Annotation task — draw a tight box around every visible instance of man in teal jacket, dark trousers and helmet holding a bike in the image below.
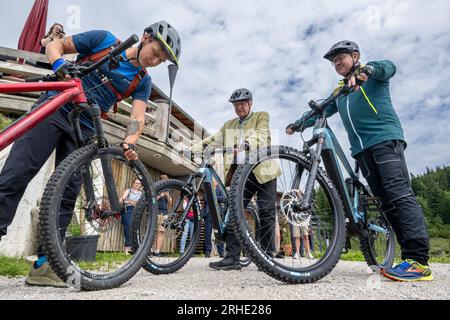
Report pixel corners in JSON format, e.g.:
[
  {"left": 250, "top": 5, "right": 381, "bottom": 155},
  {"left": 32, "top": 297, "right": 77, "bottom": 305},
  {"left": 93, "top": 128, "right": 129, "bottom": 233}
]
[{"left": 286, "top": 41, "right": 433, "bottom": 281}]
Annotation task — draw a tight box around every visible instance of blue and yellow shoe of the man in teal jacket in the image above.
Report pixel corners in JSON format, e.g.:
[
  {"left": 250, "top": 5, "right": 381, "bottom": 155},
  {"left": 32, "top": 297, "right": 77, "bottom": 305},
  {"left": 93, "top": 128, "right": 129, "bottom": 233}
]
[{"left": 381, "top": 260, "right": 433, "bottom": 281}]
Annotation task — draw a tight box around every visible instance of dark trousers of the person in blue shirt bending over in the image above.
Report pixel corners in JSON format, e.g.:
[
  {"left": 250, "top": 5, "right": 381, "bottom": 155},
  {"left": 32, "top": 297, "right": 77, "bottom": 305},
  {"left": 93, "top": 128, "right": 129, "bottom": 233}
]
[{"left": 0, "top": 95, "right": 94, "bottom": 253}]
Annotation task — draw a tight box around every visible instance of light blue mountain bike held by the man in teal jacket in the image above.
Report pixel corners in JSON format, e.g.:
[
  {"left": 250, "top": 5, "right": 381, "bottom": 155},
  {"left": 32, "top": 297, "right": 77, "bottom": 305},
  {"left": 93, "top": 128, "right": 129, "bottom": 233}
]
[{"left": 230, "top": 87, "right": 395, "bottom": 283}]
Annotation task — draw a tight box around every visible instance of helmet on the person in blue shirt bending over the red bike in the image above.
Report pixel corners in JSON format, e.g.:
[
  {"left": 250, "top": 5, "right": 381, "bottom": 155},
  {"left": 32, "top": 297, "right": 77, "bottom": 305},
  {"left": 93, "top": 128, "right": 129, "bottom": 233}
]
[{"left": 144, "top": 21, "right": 181, "bottom": 66}]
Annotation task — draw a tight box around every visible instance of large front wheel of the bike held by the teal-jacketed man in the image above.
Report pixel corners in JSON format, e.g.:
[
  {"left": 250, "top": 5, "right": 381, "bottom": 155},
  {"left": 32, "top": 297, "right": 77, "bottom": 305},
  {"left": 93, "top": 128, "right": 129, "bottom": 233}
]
[{"left": 230, "top": 146, "right": 346, "bottom": 283}]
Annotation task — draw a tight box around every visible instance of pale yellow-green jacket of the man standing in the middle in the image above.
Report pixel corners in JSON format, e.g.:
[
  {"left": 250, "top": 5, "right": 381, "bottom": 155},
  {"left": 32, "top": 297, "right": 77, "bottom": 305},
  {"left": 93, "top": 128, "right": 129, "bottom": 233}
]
[{"left": 191, "top": 112, "right": 281, "bottom": 184}]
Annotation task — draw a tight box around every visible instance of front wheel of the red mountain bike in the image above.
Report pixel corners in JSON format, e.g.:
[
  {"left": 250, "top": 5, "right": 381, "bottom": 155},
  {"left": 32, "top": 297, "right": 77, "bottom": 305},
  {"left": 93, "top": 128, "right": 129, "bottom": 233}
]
[{"left": 39, "top": 144, "right": 156, "bottom": 291}]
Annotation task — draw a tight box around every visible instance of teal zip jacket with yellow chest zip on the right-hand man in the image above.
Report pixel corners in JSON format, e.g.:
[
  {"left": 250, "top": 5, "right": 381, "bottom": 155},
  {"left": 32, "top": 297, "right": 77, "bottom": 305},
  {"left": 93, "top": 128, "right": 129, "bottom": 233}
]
[{"left": 297, "top": 60, "right": 405, "bottom": 156}]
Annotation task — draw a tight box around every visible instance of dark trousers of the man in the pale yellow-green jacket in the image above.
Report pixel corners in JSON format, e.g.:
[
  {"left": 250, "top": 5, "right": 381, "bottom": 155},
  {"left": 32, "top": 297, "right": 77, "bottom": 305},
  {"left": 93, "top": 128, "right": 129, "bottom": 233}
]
[{"left": 225, "top": 173, "right": 277, "bottom": 260}]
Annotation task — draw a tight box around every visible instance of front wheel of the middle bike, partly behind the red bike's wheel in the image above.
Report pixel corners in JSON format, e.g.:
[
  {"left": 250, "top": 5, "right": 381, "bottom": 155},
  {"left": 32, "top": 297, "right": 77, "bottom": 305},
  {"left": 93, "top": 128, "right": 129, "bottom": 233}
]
[{"left": 131, "top": 180, "right": 201, "bottom": 275}]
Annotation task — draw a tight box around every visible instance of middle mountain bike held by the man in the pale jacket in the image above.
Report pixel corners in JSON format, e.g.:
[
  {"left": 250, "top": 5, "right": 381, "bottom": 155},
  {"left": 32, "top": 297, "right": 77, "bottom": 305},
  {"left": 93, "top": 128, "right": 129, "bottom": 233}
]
[{"left": 132, "top": 150, "right": 259, "bottom": 275}]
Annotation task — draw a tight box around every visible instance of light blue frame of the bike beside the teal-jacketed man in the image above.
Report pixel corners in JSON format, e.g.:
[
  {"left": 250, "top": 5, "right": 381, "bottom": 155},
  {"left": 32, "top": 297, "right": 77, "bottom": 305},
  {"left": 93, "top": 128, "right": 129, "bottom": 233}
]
[{"left": 305, "top": 117, "right": 388, "bottom": 233}]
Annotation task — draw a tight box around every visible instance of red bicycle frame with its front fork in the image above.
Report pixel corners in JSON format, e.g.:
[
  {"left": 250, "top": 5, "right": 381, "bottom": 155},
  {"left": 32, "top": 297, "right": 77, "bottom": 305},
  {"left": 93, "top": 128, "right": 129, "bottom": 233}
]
[{"left": 0, "top": 78, "right": 121, "bottom": 212}]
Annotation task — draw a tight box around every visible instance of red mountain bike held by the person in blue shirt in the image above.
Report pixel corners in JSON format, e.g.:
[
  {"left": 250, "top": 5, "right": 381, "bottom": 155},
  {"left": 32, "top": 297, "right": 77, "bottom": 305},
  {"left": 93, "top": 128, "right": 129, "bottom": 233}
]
[{"left": 0, "top": 35, "right": 156, "bottom": 290}]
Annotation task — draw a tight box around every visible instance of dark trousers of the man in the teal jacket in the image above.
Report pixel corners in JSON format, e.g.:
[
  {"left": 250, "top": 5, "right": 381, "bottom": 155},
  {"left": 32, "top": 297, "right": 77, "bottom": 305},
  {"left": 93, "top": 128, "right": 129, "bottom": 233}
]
[{"left": 356, "top": 140, "right": 430, "bottom": 263}]
